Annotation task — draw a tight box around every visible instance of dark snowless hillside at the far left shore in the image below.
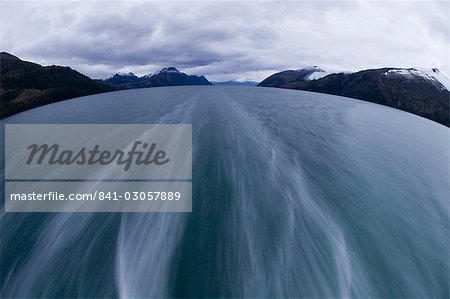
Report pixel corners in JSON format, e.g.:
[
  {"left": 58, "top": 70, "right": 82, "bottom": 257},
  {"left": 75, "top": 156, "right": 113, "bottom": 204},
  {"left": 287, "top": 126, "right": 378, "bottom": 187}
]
[{"left": 0, "top": 52, "right": 113, "bottom": 118}]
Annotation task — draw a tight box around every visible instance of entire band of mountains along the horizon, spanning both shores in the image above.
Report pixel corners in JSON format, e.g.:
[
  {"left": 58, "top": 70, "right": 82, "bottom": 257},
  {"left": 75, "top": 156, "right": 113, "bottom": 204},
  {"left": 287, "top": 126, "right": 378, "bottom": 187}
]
[{"left": 0, "top": 52, "right": 450, "bottom": 127}]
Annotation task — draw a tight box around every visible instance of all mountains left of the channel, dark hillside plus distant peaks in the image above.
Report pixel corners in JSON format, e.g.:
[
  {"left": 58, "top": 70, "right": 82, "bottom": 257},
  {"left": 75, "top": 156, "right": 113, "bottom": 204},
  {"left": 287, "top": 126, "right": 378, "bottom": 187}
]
[{"left": 0, "top": 52, "right": 211, "bottom": 118}]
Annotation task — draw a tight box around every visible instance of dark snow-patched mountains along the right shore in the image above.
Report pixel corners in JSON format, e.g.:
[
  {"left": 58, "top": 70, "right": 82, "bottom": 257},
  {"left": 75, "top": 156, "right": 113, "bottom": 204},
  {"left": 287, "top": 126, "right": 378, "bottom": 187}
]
[{"left": 258, "top": 68, "right": 450, "bottom": 126}]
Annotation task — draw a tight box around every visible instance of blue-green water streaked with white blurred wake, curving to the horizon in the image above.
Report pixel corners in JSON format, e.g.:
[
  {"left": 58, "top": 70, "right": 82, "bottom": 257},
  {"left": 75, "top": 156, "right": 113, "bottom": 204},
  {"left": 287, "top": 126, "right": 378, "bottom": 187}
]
[{"left": 0, "top": 86, "right": 450, "bottom": 298}]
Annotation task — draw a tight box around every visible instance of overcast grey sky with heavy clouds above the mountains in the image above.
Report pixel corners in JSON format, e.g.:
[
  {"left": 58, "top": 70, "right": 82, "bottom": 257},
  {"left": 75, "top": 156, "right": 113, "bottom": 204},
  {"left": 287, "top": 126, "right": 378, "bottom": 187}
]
[{"left": 0, "top": 1, "right": 450, "bottom": 81}]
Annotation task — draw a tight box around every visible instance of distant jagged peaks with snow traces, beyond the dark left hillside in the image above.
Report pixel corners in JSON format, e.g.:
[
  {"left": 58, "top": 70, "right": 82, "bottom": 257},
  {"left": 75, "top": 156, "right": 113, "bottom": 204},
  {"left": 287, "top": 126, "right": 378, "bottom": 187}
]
[{"left": 105, "top": 67, "right": 212, "bottom": 89}]
